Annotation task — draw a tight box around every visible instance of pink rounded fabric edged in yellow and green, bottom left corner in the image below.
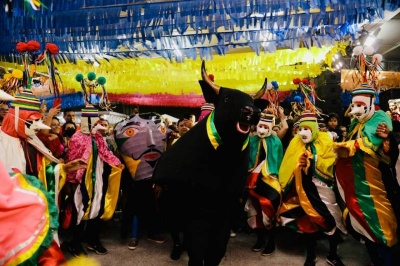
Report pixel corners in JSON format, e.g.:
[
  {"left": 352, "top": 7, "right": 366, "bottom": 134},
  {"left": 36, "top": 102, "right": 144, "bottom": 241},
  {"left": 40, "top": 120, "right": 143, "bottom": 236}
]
[{"left": 0, "top": 163, "right": 65, "bottom": 265}]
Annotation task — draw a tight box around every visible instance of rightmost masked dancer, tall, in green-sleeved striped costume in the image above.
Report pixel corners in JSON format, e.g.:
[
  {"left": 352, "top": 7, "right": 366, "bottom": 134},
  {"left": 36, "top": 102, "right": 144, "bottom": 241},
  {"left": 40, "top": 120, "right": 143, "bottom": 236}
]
[{"left": 335, "top": 84, "right": 400, "bottom": 265}]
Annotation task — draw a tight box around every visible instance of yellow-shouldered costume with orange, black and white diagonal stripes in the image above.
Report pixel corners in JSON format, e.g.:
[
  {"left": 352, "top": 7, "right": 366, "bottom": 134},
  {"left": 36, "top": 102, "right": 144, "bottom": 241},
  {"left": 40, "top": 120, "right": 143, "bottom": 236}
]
[{"left": 279, "top": 132, "right": 346, "bottom": 233}]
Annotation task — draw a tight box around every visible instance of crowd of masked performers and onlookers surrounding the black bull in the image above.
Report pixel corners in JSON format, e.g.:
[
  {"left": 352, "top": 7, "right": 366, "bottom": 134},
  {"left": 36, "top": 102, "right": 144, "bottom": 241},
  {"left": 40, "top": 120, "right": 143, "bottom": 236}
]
[{"left": 0, "top": 79, "right": 400, "bottom": 265}]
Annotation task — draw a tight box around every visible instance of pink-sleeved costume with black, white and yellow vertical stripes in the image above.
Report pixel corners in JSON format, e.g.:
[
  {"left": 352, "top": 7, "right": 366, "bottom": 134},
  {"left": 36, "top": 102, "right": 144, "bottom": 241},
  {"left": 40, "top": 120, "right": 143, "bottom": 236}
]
[{"left": 67, "top": 123, "right": 122, "bottom": 224}]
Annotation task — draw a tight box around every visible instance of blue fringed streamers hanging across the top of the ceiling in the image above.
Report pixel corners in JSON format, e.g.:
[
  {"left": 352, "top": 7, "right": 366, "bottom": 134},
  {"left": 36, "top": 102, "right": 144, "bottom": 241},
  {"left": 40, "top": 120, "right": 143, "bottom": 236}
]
[{"left": 0, "top": 0, "right": 399, "bottom": 61}]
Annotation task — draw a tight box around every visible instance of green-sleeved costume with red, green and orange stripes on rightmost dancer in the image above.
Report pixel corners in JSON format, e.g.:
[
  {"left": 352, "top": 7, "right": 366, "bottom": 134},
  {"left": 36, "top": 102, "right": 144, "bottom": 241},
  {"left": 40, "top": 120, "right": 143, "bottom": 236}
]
[{"left": 335, "top": 110, "right": 399, "bottom": 247}]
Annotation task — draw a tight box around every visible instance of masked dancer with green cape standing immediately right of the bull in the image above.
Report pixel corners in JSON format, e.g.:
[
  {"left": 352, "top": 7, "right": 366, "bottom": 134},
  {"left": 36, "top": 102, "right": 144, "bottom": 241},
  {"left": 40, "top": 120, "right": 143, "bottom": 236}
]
[{"left": 245, "top": 112, "right": 283, "bottom": 256}]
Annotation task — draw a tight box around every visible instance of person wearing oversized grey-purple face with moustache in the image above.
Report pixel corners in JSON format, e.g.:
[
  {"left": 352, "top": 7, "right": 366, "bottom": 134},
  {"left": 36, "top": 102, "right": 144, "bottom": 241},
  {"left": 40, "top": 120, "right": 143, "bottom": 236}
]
[{"left": 114, "top": 113, "right": 167, "bottom": 250}]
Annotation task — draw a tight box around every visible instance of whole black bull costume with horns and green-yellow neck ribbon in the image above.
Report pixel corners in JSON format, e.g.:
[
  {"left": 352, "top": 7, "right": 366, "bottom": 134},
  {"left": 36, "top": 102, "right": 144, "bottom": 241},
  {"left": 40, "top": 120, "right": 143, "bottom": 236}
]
[{"left": 153, "top": 61, "right": 266, "bottom": 265}]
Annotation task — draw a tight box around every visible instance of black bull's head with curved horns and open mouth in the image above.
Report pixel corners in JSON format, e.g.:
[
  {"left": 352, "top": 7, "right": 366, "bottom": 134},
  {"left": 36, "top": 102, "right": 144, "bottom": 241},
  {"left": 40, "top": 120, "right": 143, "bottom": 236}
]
[{"left": 199, "top": 61, "right": 267, "bottom": 141}]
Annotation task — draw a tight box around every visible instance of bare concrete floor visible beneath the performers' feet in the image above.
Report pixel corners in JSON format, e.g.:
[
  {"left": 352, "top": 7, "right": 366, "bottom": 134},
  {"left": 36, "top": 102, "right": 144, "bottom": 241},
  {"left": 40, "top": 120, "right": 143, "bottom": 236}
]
[{"left": 62, "top": 221, "right": 369, "bottom": 266}]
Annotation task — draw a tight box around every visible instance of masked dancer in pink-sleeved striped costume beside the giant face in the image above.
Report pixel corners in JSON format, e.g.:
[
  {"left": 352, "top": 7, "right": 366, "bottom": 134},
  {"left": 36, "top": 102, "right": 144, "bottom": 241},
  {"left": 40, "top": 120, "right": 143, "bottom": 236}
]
[{"left": 65, "top": 104, "right": 124, "bottom": 257}]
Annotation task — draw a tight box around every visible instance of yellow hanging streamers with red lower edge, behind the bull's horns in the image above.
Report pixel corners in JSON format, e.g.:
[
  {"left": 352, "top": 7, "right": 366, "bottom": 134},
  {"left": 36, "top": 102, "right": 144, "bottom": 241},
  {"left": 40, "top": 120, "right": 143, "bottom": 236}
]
[{"left": 1, "top": 43, "right": 346, "bottom": 107}]
